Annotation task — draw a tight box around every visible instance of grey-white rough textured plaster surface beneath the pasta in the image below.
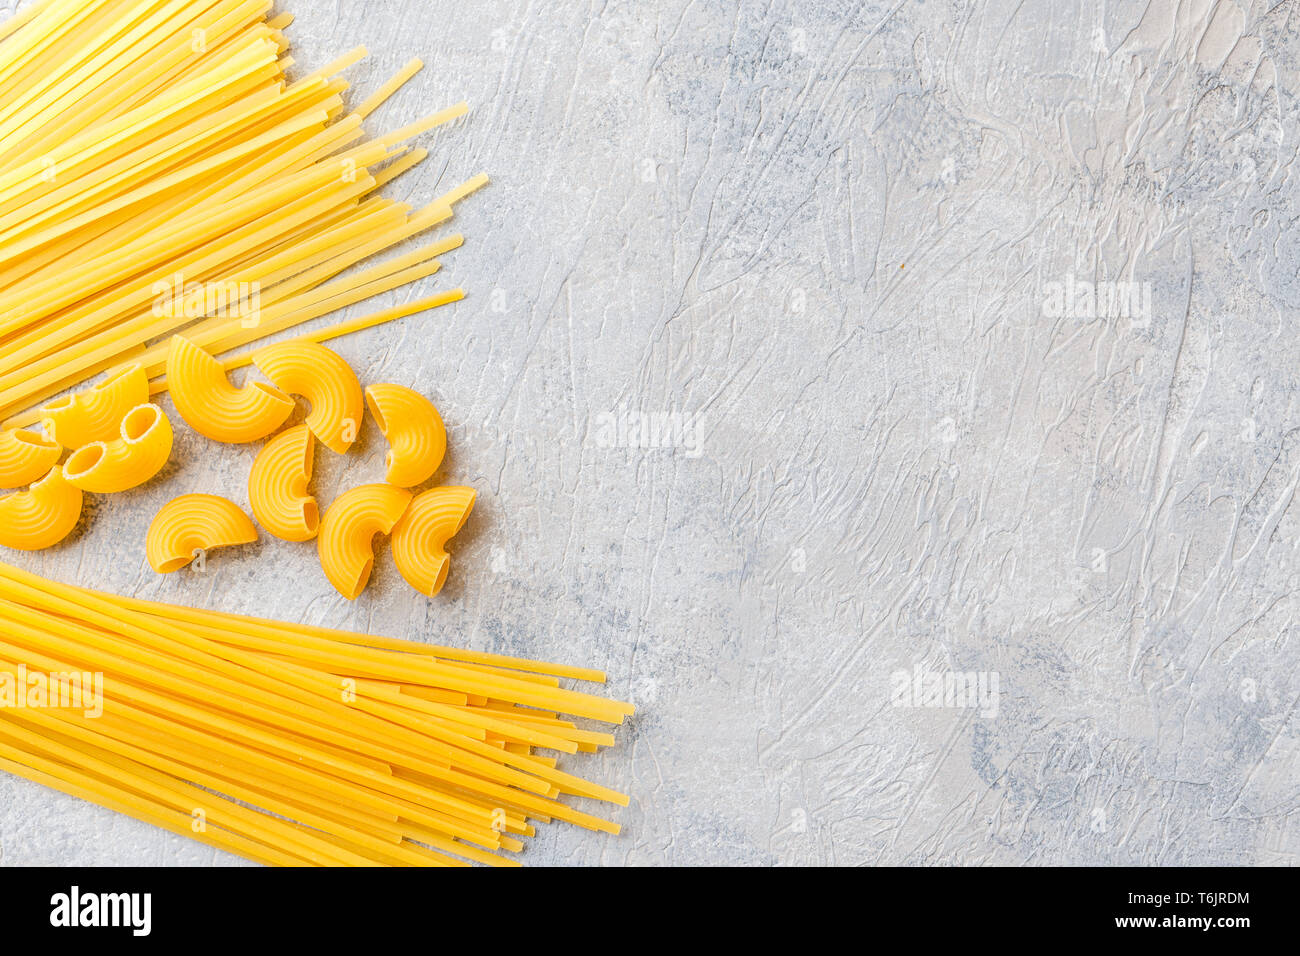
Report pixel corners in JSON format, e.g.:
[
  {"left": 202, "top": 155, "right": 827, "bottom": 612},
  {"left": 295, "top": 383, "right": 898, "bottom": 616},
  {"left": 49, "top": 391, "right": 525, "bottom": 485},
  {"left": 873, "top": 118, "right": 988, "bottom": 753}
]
[{"left": 0, "top": 0, "right": 1300, "bottom": 864}]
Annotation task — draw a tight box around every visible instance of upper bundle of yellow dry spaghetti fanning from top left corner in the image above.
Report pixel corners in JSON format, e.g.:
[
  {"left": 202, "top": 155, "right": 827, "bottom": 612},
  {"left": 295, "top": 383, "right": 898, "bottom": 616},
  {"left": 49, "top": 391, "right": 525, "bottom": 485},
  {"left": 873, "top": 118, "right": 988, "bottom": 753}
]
[{"left": 0, "top": 0, "right": 486, "bottom": 427}]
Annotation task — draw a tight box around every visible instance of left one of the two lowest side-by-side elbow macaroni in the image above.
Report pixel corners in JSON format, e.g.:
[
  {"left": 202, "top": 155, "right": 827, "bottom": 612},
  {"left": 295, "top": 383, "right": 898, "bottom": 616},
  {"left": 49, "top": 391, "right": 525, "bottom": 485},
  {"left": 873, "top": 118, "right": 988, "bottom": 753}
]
[{"left": 316, "top": 484, "right": 411, "bottom": 601}]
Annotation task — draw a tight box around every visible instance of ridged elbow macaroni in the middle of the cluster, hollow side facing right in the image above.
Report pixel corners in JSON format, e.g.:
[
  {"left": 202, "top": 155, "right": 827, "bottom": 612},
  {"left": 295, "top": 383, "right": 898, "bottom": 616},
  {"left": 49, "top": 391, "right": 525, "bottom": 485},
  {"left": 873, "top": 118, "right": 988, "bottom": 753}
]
[{"left": 248, "top": 425, "right": 320, "bottom": 541}]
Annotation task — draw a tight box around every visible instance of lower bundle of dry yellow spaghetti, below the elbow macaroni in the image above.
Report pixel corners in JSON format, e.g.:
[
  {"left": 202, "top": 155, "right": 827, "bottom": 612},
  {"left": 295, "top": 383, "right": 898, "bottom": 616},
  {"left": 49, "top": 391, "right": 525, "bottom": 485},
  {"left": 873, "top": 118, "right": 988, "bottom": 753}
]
[{"left": 0, "top": 563, "right": 633, "bottom": 866}]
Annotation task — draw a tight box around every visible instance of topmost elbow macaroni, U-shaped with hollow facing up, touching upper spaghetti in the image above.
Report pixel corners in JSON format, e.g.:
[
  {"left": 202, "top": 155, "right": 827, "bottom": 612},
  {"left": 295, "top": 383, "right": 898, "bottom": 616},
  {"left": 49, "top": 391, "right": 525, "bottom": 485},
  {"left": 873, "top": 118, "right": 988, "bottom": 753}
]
[{"left": 166, "top": 336, "right": 294, "bottom": 444}]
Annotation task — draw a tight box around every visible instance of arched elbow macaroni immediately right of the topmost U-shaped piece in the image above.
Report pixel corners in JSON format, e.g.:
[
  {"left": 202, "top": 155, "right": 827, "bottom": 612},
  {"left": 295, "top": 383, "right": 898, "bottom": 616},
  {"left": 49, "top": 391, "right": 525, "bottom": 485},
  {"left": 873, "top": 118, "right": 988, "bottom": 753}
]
[{"left": 252, "top": 342, "right": 364, "bottom": 454}]
